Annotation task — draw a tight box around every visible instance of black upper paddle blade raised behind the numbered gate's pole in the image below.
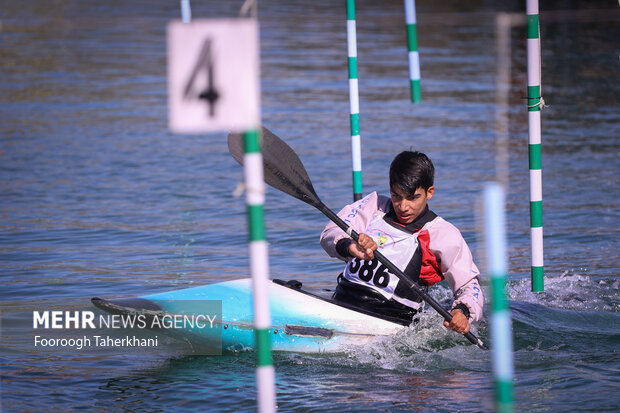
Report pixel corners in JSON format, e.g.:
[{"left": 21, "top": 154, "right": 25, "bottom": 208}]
[{"left": 228, "top": 127, "right": 322, "bottom": 208}]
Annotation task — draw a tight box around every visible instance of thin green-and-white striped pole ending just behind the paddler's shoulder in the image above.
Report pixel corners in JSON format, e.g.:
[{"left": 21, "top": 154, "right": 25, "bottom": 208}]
[{"left": 347, "top": 0, "right": 362, "bottom": 201}]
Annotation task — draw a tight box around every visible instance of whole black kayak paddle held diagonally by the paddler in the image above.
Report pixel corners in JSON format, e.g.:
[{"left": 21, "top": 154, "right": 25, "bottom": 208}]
[{"left": 228, "top": 127, "right": 488, "bottom": 350}]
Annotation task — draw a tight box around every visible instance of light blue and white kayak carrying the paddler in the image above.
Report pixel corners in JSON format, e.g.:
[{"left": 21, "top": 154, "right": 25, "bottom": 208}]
[{"left": 92, "top": 279, "right": 408, "bottom": 353}]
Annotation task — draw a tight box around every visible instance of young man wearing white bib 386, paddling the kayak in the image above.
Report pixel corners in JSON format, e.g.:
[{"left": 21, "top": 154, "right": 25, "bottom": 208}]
[{"left": 321, "top": 151, "right": 484, "bottom": 334}]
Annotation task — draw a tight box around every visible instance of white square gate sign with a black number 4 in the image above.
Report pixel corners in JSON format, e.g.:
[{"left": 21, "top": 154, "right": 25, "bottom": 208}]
[{"left": 168, "top": 19, "right": 260, "bottom": 133}]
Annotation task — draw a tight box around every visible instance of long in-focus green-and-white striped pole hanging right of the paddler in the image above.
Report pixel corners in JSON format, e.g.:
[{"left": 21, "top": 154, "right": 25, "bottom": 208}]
[{"left": 526, "top": 0, "right": 544, "bottom": 292}]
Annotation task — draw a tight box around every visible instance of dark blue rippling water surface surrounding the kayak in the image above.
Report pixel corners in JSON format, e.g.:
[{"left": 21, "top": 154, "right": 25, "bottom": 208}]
[{"left": 0, "top": 0, "right": 620, "bottom": 412}]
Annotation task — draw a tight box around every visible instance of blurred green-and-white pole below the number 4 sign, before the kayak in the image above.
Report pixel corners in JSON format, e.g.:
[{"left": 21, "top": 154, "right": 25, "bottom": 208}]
[{"left": 243, "top": 130, "right": 276, "bottom": 412}]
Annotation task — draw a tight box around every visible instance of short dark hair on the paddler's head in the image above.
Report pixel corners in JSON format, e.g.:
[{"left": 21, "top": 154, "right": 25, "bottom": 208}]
[{"left": 390, "top": 151, "right": 435, "bottom": 195}]
